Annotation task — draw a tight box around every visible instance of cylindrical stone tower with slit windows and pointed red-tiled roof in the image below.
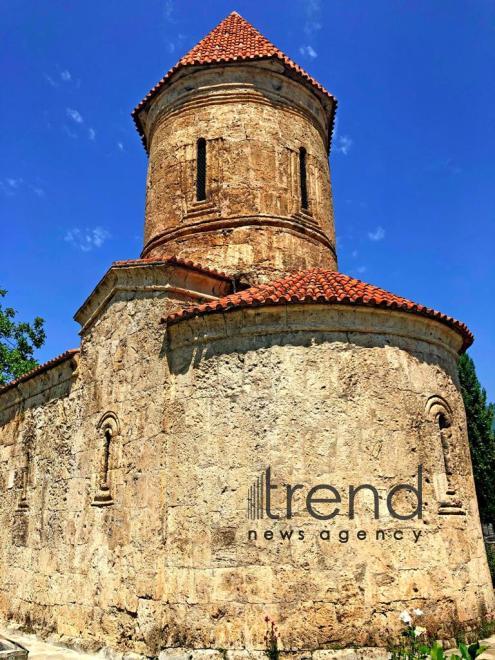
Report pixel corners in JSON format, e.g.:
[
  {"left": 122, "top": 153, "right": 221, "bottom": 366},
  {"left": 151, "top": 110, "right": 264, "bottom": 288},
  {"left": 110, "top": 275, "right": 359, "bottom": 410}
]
[{"left": 134, "top": 12, "right": 337, "bottom": 283}]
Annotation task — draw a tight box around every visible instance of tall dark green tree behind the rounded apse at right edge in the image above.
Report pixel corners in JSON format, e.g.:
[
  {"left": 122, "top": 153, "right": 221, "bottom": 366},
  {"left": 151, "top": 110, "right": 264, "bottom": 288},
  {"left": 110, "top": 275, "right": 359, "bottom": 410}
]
[{"left": 459, "top": 353, "right": 495, "bottom": 523}]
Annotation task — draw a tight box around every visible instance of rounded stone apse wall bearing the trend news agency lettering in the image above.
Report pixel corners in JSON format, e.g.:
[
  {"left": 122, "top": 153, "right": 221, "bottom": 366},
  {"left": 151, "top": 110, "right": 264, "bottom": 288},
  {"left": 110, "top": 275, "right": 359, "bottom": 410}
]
[{"left": 161, "top": 305, "right": 494, "bottom": 649}]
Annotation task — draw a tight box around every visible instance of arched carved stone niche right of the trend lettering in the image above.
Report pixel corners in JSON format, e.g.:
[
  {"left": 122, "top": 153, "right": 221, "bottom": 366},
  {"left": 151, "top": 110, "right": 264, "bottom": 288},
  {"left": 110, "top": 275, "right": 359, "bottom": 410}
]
[{"left": 426, "top": 394, "right": 466, "bottom": 516}]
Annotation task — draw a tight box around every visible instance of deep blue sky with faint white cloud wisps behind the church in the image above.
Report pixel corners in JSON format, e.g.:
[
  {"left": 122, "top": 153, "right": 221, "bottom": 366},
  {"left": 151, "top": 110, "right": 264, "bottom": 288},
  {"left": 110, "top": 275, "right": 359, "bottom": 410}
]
[{"left": 0, "top": 0, "right": 495, "bottom": 400}]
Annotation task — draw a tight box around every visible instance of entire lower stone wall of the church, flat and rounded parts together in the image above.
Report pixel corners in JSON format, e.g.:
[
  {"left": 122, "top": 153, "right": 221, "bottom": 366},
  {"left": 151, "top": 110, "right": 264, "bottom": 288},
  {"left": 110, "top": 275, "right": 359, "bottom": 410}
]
[{"left": 0, "top": 292, "right": 493, "bottom": 655}]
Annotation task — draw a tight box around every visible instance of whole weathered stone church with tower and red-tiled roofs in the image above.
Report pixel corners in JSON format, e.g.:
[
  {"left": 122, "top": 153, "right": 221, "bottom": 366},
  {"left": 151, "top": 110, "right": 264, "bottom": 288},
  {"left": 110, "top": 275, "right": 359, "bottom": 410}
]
[{"left": 0, "top": 13, "right": 494, "bottom": 658}]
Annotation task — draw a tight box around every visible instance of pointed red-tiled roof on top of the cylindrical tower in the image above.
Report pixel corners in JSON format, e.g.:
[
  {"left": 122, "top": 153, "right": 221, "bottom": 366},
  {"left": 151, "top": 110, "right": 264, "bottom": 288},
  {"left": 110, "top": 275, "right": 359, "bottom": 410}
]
[{"left": 132, "top": 11, "right": 336, "bottom": 147}]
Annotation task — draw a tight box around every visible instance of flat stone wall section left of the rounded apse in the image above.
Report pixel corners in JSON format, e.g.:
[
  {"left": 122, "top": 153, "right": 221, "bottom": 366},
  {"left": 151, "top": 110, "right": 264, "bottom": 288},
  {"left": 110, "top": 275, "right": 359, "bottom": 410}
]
[{"left": 0, "top": 284, "right": 200, "bottom": 652}]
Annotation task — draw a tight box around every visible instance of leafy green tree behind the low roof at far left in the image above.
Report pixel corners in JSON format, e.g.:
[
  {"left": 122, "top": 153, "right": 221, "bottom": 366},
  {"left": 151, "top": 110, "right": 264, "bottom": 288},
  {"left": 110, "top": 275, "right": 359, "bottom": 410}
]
[{"left": 0, "top": 289, "right": 46, "bottom": 385}]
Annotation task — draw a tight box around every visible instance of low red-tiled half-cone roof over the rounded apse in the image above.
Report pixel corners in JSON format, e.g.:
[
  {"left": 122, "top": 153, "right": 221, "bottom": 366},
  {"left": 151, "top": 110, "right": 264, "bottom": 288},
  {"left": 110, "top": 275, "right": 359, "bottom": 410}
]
[{"left": 164, "top": 268, "right": 473, "bottom": 351}]
